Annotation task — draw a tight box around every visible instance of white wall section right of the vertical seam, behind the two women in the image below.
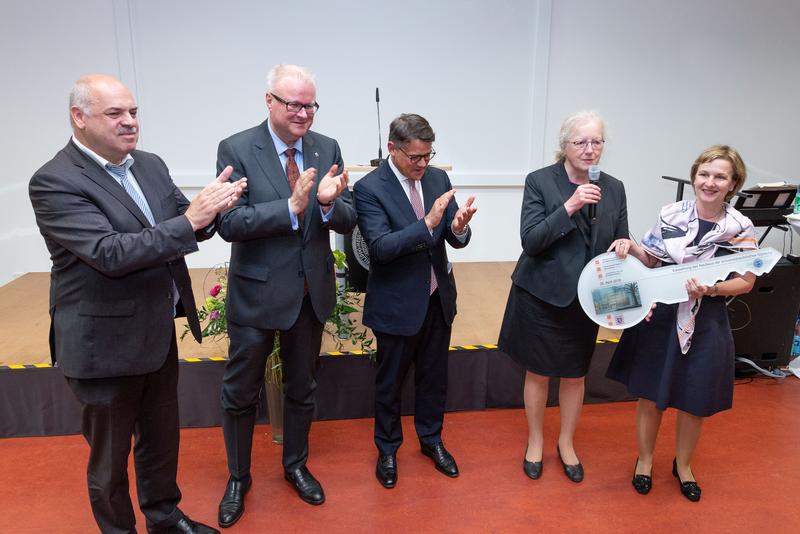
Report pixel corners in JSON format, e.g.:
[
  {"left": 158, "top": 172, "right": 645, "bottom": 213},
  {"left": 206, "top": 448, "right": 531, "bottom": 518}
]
[{"left": 546, "top": 0, "right": 800, "bottom": 247}]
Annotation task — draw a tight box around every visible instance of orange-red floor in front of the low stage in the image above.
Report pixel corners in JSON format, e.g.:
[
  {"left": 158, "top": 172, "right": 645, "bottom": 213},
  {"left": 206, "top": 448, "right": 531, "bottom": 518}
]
[{"left": 0, "top": 377, "right": 800, "bottom": 534}]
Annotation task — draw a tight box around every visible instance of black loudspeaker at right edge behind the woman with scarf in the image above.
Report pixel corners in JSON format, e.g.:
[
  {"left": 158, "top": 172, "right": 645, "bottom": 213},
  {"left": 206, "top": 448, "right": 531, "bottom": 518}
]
[{"left": 728, "top": 258, "right": 800, "bottom": 368}]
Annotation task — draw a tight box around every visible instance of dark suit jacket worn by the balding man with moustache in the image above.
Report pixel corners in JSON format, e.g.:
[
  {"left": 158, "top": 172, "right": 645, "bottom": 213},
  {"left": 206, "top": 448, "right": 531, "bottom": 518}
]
[{"left": 29, "top": 141, "right": 210, "bottom": 378}]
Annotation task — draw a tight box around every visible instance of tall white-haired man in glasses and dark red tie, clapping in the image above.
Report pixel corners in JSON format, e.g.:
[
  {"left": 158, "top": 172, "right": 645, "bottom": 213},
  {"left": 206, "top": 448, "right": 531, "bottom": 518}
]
[{"left": 217, "top": 65, "right": 355, "bottom": 527}]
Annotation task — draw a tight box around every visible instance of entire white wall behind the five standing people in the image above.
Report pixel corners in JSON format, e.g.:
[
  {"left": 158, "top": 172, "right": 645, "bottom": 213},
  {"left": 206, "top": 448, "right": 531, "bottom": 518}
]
[{"left": 0, "top": 0, "right": 800, "bottom": 284}]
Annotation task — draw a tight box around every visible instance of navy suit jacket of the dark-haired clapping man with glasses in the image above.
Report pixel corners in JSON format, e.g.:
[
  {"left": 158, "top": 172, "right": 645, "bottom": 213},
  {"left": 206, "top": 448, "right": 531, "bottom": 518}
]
[{"left": 353, "top": 161, "right": 472, "bottom": 336}]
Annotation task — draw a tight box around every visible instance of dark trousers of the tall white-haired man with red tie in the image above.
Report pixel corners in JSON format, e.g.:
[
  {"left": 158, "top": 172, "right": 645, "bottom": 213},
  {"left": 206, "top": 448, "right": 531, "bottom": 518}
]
[{"left": 222, "top": 296, "right": 323, "bottom": 479}]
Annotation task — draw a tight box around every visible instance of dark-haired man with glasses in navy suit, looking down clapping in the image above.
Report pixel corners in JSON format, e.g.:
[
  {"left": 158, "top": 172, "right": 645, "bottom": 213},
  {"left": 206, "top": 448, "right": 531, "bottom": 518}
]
[{"left": 353, "top": 114, "right": 477, "bottom": 488}]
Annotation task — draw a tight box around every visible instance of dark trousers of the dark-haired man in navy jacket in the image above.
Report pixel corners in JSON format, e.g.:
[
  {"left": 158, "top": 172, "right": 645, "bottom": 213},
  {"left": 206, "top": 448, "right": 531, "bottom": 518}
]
[{"left": 375, "top": 292, "right": 451, "bottom": 455}]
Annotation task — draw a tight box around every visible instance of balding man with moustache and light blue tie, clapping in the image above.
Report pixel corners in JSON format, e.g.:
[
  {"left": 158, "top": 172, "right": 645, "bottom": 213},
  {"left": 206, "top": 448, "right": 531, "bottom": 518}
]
[{"left": 29, "top": 75, "right": 244, "bottom": 533}]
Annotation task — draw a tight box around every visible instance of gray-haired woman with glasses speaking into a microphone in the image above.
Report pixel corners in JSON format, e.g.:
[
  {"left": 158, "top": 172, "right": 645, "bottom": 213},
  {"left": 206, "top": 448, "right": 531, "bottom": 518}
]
[{"left": 498, "top": 111, "right": 628, "bottom": 482}]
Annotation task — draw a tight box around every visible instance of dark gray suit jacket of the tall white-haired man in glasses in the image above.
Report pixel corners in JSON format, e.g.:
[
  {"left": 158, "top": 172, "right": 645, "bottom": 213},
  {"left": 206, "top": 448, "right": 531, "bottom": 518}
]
[{"left": 217, "top": 121, "right": 356, "bottom": 330}]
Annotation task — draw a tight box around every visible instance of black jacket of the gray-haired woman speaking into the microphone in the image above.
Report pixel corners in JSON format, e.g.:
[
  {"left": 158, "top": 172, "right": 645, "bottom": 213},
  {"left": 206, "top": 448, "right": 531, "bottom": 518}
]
[{"left": 511, "top": 162, "right": 628, "bottom": 307}]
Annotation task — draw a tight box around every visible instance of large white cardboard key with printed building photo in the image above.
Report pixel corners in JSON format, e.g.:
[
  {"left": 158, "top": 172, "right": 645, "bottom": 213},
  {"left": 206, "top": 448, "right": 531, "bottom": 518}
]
[{"left": 578, "top": 247, "right": 781, "bottom": 329}]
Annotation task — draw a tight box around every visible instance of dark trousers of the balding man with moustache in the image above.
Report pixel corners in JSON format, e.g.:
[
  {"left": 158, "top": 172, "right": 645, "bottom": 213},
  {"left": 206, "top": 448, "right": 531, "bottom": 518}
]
[{"left": 67, "top": 334, "right": 183, "bottom": 533}]
